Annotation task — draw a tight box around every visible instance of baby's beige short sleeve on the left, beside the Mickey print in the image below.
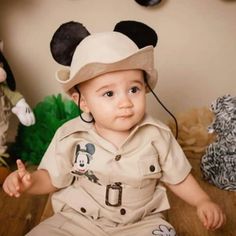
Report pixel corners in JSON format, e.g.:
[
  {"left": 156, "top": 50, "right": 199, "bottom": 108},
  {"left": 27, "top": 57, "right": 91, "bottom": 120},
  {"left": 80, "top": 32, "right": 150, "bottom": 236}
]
[{"left": 38, "top": 128, "right": 73, "bottom": 188}]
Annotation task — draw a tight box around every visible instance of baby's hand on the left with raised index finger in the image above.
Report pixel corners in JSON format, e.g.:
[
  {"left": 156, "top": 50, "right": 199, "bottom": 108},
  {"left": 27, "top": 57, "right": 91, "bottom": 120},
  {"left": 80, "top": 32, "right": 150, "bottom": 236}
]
[{"left": 3, "top": 160, "right": 32, "bottom": 197}]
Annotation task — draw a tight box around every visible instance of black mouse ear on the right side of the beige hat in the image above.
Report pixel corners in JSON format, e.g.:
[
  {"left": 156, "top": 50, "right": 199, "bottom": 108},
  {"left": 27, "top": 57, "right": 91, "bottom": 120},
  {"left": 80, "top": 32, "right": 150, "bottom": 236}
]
[{"left": 114, "top": 21, "right": 158, "bottom": 48}]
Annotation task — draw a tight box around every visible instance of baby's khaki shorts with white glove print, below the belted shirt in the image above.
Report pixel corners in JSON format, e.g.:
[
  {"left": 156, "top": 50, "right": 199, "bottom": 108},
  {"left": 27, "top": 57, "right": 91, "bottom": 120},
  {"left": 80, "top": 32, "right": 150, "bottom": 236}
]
[{"left": 27, "top": 208, "right": 176, "bottom": 236}]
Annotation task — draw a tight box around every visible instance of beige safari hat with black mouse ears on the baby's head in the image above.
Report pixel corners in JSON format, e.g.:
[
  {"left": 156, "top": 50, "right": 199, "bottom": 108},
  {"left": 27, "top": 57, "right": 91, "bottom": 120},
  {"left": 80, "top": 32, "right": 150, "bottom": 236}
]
[{"left": 50, "top": 21, "right": 158, "bottom": 94}]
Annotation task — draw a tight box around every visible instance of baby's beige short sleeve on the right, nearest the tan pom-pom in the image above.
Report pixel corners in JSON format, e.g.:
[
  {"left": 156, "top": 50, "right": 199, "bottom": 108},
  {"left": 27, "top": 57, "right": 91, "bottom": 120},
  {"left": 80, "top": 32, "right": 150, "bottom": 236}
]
[{"left": 155, "top": 130, "right": 191, "bottom": 184}]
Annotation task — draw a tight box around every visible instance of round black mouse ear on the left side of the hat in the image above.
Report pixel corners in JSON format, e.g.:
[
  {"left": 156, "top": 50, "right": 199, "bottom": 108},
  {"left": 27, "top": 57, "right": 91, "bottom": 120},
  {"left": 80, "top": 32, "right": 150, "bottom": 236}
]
[{"left": 50, "top": 21, "right": 90, "bottom": 66}]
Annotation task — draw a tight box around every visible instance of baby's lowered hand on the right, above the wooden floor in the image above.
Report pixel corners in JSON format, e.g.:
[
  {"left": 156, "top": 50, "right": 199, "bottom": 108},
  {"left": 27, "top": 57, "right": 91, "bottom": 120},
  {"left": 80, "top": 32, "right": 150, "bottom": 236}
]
[{"left": 197, "top": 199, "right": 226, "bottom": 230}]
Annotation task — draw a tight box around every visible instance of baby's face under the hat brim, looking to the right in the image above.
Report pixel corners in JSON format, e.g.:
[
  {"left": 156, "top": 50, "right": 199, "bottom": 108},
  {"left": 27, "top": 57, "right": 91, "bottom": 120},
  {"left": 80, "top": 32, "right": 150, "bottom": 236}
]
[{"left": 72, "top": 70, "right": 146, "bottom": 131}]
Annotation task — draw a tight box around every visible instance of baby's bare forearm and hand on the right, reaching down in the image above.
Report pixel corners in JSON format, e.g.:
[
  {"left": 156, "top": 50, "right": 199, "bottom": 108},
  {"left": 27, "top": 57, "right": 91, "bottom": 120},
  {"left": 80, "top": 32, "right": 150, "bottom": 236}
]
[{"left": 167, "top": 174, "right": 225, "bottom": 230}]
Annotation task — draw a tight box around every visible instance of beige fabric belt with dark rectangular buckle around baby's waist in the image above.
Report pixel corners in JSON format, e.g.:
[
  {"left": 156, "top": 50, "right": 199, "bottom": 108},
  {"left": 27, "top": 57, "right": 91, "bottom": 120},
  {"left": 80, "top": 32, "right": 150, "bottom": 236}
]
[{"left": 79, "top": 178, "right": 156, "bottom": 207}]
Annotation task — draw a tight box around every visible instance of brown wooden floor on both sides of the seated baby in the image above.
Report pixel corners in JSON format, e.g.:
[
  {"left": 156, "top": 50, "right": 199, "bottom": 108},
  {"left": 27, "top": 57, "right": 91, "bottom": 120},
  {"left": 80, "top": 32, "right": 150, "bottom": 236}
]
[{"left": 0, "top": 158, "right": 236, "bottom": 236}]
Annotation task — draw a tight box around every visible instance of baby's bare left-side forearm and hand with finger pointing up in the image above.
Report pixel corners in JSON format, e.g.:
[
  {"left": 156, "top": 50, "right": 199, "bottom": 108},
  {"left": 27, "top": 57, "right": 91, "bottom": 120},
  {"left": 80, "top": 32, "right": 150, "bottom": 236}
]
[{"left": 3, "top": 160, "right": 57, "bottom": 197}]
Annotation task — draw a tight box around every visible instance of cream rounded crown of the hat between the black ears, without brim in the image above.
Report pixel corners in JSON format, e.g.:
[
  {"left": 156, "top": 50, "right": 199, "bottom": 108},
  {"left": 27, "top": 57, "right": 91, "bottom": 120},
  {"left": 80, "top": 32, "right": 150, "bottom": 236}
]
[{"left": 70, "top": 31, "right": 139, "bottom": 78}]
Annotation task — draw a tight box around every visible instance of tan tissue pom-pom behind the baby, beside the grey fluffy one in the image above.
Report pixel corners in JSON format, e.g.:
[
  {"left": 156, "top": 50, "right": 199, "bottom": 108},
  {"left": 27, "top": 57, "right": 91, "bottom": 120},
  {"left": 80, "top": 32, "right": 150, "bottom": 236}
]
[{"left": 169, "top": 107, "right": 215, "bottom": 158}]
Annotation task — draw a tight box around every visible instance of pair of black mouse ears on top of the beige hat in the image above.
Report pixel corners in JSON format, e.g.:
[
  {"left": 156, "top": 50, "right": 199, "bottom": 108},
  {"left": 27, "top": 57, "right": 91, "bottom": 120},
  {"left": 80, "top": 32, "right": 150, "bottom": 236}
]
[{"left": 50, "top": 21, "right": 158, "bottom": 66}]
